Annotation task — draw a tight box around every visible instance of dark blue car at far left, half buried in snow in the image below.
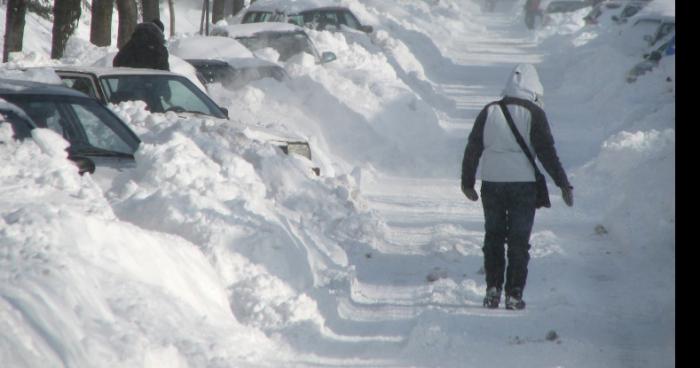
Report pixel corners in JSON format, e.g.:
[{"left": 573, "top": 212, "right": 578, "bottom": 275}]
[{"left": 0, "top": 79, "right": 141, "bottom": 173}]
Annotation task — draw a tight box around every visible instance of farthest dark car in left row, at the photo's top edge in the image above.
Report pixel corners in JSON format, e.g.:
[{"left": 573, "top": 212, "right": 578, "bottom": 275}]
[{"left": 241, "top": 0, "right": 374, "bottom": 33}]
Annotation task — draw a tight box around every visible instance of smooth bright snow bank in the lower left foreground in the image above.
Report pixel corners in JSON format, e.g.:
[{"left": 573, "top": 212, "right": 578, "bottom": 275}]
[{"left": 0, "top": 124, "right": 278, "bottom": 367}]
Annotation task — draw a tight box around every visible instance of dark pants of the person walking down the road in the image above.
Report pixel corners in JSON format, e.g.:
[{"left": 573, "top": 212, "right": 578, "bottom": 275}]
[{"left": 481, "top": 181, "right": 537, "bottom": 295}]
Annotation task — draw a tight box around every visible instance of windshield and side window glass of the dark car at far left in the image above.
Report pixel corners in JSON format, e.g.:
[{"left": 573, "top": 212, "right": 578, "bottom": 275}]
[{"left": 2, "top": 95, "right": 140, "bottom": 154}]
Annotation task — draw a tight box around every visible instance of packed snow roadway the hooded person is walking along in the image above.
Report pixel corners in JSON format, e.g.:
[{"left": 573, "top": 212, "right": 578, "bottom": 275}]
[{"left": 278, "top": 8, "right": 674, "bottom": 367}]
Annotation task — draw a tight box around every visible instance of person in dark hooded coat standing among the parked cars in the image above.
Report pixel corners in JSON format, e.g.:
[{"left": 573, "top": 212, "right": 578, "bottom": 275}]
[{"left": 112, "top": 19, "right": 170, "bottom": 70}]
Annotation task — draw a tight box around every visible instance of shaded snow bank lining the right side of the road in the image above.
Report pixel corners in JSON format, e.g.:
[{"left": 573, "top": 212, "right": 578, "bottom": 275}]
[{"left": 541, "top": 0, "right": 676, "bottom": 252}]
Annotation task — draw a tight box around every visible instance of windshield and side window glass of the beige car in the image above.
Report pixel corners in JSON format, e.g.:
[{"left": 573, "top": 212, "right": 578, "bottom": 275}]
[{"left": 95, "top": 74, "right": 226, "bottom": 119}]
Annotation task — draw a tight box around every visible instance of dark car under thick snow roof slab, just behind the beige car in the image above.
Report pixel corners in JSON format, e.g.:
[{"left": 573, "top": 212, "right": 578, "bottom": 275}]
[{"left": 169, "top": 36, "right": 289, "bottom": 89}]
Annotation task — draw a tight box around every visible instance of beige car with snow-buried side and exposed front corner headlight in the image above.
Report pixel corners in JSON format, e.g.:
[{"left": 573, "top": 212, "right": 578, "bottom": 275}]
[{"left": 53, "top": 66, "right": 318, "bottom": 171}]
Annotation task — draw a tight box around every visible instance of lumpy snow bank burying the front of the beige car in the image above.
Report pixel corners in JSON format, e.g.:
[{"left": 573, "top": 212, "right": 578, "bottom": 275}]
[{"left": 107, "top": 103, "right": 382, "bottom": 336}]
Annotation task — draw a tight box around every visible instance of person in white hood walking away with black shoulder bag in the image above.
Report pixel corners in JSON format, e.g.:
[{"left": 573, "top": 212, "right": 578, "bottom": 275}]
[{"left": 461, "top": 64, "right": 574, "bottom": 309}]
